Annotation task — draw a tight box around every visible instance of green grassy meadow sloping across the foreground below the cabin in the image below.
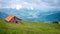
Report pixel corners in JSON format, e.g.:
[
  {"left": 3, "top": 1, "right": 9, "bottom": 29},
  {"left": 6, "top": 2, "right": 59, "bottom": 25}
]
[{"left": 0, "top": 18, "right": 60, "bottom": 34}]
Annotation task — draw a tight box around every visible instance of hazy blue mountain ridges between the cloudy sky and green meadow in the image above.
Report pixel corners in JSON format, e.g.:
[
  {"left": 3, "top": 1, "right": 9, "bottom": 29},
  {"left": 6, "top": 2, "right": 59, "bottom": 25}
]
[{"left": 0, "top": 8, "right": 60, "bottom": 21}]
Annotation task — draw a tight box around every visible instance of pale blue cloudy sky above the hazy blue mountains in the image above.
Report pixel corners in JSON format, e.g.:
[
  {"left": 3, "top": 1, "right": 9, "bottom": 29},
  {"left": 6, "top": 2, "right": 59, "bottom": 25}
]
[{"left": 0, "top": 0, "right": 60, "bottom": 10}]
